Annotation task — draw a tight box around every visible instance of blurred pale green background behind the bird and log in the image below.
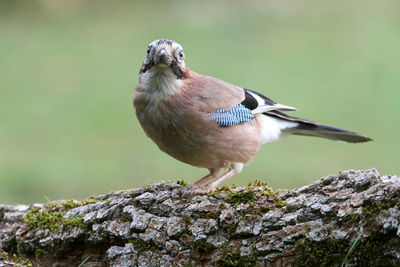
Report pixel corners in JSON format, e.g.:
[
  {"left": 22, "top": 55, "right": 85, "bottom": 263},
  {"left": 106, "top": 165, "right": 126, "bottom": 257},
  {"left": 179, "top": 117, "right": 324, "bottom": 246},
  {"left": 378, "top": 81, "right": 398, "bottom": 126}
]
[{"left": 0, "top": 0, "right": 400, "bottom": 203}]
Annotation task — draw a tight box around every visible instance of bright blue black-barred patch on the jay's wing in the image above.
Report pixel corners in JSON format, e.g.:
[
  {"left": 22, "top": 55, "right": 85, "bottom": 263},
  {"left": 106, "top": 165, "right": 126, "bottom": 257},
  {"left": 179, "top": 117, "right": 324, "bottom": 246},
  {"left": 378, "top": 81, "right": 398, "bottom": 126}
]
[{"left": 208, "top": 104, "right": 254, "bottom": 127}]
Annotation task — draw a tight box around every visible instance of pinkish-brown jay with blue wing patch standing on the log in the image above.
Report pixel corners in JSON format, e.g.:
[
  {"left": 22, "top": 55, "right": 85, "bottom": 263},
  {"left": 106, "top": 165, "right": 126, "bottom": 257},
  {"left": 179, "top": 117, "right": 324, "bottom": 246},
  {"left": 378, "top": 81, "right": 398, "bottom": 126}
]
[{"left": 133, "top": 39, "right": 372, "bottom": 193}]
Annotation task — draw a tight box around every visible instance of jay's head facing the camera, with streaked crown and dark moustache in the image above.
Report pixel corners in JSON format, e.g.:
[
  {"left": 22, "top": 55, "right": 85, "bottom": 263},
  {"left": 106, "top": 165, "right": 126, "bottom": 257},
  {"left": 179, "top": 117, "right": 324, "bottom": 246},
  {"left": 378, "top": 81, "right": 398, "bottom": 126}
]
[{"left": 140, "top": 39, "right": 188, "bottom": 79}]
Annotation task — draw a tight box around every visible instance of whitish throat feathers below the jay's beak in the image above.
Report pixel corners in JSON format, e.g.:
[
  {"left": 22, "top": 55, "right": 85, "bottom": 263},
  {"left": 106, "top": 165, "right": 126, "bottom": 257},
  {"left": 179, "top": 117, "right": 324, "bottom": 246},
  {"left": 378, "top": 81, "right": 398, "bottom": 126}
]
[{"left": 140, "top": 65, "right": 181, "bottom": 102}]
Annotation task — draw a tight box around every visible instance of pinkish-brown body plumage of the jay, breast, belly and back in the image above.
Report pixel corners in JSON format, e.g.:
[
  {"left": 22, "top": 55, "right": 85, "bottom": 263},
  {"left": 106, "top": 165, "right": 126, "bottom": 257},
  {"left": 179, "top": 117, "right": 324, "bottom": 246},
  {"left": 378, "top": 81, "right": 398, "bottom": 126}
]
[{"left": 134, "top": 72, "right": 261, "bottom": 169}]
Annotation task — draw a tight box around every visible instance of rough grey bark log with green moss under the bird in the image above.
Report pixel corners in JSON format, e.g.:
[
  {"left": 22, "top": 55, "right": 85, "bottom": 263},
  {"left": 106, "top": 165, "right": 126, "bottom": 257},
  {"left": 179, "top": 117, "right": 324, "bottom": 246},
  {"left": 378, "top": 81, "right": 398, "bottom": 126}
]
[{"left": 0, "top": 169, "right": 400, "bottom": 266}]
